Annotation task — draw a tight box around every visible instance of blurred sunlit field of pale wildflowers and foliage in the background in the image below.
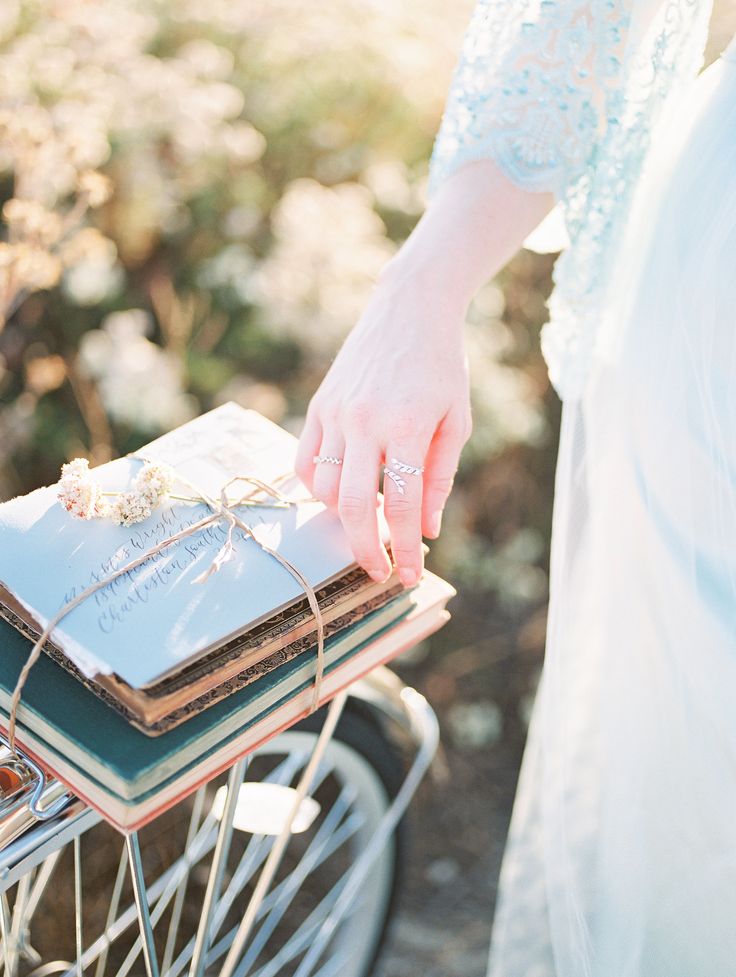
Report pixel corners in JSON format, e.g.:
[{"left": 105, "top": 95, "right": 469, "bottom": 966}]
[{"left": 0, "top": 0, "right": 736, "bottom": 977}]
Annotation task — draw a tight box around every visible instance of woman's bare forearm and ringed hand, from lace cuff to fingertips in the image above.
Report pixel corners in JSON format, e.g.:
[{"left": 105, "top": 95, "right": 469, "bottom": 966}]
[{"left": 296, "top": 159, "right": 554, "bottom": 586}]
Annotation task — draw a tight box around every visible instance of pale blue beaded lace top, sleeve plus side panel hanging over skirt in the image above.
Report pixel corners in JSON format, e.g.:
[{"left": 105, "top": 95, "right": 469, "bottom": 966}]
[{"left": 428, "top": 0, "right": 712, "bottom": 399}]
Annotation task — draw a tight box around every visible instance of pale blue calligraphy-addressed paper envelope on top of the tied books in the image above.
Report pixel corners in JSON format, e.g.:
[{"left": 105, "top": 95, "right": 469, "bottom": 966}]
[{"left": 0, "top": 403, "right": 390, "bottom": 688}]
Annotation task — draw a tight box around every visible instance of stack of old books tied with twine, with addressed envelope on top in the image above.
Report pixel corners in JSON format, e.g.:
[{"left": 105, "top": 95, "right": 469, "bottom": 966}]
[{"left": 0, "top": 403, "right": 455, "bottom": 830}]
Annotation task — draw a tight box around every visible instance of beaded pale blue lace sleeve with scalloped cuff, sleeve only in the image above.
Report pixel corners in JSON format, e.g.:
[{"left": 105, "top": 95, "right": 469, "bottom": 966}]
[{"left": 428, "top": 0, "right": 633, "bottom": 199}]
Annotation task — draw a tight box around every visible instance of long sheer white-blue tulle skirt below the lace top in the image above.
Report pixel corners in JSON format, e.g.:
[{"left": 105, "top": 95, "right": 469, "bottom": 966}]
[{"left": 488, "top": 42, "right": 736, "bottom": 977}]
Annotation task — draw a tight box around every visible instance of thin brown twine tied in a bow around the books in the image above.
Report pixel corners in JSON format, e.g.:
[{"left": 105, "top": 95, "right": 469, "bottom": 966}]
[{"left": 8, "top": 453, "right": 325, "bottom": 751}]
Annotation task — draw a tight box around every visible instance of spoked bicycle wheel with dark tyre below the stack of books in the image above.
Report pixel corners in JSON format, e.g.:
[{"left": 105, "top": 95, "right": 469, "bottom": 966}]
[{"left": 2, "top": 705, "right": 405, "bottom": 977}]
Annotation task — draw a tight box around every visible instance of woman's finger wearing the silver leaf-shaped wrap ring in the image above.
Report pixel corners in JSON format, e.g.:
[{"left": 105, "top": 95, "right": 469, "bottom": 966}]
[{"left": 383, "top": 430, "right": 427, "bottom": 586}]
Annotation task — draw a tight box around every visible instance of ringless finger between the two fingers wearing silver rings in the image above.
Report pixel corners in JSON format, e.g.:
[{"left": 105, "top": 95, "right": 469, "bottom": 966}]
[{"left": 337, "top": 432, "right": 392, "bottom": 581}]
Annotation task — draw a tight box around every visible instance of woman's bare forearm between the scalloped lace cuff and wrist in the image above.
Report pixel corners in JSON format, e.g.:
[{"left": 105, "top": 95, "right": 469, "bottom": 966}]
[{"left": 381, "top": 159, "right": 554, "bottom": 310}]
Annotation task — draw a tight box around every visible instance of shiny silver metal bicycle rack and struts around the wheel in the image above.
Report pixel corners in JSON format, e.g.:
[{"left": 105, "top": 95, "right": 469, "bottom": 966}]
[{"left": 0, "top": 666, "right": 439, "bottom": 977}]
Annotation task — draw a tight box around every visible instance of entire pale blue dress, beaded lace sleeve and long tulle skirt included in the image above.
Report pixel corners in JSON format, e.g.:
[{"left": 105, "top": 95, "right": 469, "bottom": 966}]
[{"left": 431, "top": 0, "right": 736, "bottom": 977}]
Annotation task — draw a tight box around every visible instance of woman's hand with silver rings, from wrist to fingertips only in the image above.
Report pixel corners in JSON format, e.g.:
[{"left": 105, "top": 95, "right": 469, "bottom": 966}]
[{"left": 296, "top": 255, "right": 472, "bottom": 586}]
